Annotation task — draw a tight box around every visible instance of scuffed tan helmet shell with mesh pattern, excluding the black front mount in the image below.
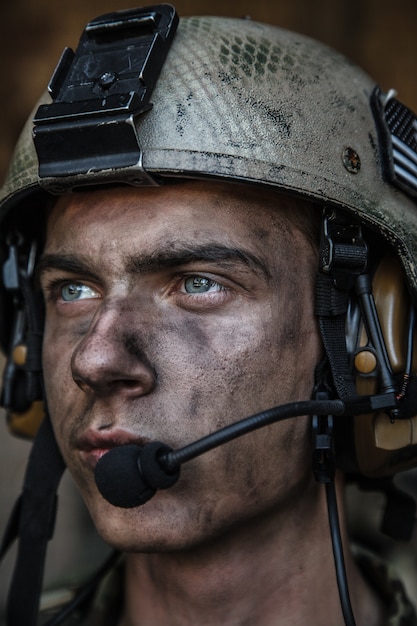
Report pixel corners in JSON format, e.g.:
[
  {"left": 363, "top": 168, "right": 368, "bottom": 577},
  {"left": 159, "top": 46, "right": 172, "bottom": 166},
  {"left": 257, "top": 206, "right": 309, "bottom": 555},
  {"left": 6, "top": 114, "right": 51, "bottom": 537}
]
[{"left": 0, "top": 17, "right": 417, "bottom": 294}]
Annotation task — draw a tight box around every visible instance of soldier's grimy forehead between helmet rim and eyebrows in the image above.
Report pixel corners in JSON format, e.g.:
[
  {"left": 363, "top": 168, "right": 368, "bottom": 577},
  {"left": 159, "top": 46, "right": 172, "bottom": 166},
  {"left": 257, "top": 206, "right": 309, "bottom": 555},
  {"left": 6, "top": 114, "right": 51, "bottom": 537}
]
[{"left": 46, "top": 181, "right": 312, "bottom": 260}]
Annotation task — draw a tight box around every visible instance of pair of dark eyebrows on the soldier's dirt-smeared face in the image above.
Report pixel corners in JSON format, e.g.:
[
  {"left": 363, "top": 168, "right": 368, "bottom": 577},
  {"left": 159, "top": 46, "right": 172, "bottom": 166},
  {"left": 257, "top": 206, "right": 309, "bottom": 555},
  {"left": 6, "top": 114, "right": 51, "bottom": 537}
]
[{"left": 36, "top": 243, "right": 271, "bottom": 279}]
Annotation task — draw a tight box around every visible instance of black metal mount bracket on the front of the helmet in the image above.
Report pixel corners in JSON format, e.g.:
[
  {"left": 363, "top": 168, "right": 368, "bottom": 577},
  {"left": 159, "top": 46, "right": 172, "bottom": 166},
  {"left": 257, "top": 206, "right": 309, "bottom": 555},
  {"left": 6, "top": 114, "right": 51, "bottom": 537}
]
[{"left": 33, "top": 4, "right": 178, "bottom": 193}]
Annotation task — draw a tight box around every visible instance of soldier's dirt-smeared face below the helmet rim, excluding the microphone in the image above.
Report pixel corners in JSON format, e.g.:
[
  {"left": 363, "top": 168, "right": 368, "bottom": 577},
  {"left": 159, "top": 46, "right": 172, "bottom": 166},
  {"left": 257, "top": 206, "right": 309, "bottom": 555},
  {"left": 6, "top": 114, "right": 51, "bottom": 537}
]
[{"left": 41, "top": 183, "right": 320, "bottom": 550}]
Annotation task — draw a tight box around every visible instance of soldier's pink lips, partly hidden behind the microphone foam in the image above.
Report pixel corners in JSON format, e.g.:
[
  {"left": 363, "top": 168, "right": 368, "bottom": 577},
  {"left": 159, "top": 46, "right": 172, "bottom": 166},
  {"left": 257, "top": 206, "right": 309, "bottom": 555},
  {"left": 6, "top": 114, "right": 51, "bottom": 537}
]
[{"left": 76, "top": 430, "right": 146, "bottom": 469}]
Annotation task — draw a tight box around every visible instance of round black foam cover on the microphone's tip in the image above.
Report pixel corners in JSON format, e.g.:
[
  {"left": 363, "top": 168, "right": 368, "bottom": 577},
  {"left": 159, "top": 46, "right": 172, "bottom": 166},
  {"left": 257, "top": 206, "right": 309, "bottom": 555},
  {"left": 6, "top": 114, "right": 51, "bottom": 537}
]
[{"left": 94, "top": 442, "right": 180, "bottom": 509}]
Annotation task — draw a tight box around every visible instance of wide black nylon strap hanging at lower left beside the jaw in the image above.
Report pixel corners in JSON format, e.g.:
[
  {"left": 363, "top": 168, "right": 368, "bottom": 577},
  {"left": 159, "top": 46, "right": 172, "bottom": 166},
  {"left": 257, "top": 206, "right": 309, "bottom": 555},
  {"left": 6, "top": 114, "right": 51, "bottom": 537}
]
[{"left": 3, "top": 417, "right": 65, "bottom": 626}]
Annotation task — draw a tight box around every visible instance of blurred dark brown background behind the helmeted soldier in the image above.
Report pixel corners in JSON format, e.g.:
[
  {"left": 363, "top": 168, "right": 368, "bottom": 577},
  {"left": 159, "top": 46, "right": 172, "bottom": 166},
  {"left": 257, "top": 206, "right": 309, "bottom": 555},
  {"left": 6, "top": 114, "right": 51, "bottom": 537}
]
[{"left": 0, "top": 0, "right": 417, "bottom": 621}]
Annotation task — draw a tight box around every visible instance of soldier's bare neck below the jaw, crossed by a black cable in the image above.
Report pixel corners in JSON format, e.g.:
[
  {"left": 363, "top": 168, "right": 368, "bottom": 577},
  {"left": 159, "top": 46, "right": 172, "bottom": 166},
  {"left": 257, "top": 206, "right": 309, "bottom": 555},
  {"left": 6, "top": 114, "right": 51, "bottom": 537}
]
[{"left": 120, "top": 472, "right": 380, "bottom": 626}]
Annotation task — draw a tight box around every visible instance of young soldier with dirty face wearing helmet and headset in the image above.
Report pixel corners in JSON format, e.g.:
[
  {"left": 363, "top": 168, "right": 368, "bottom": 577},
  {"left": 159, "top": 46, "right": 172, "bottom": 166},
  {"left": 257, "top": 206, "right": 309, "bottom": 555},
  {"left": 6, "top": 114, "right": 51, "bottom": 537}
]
[{"left": 0, "top": 5, "right": 417, "bottom": 626}]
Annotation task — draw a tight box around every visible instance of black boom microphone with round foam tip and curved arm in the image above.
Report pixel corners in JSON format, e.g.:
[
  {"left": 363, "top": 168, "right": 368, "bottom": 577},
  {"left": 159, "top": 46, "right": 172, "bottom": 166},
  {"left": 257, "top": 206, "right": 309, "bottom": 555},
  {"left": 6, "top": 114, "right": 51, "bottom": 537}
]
[{"left": 95, "top": 400, "right": 346, "bottom": 508}]
